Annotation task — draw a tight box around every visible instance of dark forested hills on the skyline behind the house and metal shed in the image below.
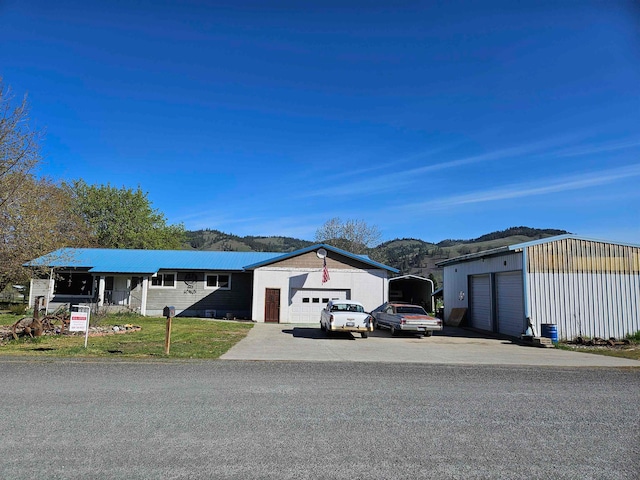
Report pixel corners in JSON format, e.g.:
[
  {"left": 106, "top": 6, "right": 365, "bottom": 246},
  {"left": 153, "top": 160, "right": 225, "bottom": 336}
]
[{"left": 185, "top": 227, "right": 568, "bottom": 284}]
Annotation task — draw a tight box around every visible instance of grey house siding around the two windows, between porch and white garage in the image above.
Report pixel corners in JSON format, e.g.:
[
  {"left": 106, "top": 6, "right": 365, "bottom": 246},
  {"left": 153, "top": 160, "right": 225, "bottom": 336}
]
[{"left": 147, "top": 270, "right": 253, "bottom": 318}]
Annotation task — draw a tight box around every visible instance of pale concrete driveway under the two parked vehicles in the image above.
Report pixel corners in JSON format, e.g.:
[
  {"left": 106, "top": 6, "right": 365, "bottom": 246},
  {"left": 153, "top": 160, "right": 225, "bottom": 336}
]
[{"left": 221, "top": 323, "right": 640, "bottom": 367}]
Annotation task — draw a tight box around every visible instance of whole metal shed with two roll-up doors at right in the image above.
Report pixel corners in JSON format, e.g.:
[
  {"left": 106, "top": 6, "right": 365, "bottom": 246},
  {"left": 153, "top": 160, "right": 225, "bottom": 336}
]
[{"left": 438, "top": 235, "right": 640, "bottom": 339}]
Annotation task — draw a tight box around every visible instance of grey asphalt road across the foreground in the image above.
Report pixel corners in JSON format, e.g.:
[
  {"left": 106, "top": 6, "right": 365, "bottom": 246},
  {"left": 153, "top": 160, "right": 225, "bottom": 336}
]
[{"left": 0, "top": 358, "right": 640, "bottom": 479}]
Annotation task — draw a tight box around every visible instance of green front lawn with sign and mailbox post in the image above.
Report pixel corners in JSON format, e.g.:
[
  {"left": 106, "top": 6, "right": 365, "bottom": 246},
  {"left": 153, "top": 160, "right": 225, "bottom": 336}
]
[{"left": 0, "top": 315, "right": 253, "bottom": 359}]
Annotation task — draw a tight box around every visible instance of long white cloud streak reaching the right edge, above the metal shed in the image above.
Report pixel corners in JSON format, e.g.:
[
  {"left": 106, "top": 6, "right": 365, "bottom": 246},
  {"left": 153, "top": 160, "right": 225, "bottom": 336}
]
[{"left": 404, "top": 164, "right": 640, "bottom": 209}]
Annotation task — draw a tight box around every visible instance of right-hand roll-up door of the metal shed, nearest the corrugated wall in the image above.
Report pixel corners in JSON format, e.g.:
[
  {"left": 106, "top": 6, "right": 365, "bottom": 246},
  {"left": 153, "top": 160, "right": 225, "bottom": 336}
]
[{"left": 496, "top": 272, "right": 525, "bottom": 337}]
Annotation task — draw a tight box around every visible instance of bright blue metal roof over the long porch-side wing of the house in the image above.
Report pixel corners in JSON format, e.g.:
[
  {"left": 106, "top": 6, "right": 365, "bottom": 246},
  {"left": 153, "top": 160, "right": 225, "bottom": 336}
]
[{"left": 27, "top": 248, "right": 282, "bottom": 273}]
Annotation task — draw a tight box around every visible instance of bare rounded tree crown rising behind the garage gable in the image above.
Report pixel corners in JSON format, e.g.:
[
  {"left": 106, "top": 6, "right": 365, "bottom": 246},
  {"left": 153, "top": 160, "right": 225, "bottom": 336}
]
[{"left": 315, "top": 217, "right": 382, "bottom": 253}]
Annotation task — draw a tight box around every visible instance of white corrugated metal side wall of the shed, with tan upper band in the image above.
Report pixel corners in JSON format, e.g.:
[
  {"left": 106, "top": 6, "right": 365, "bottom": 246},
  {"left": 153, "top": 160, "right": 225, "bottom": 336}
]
[{"left": 526, "top": 238, "right": 640, "bottom": 340}]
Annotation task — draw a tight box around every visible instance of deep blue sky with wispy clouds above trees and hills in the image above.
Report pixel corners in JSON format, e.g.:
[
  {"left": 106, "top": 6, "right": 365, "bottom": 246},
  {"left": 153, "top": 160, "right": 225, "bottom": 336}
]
[{"left": 0, "top": 0, "right": 640, "bottom": 243}]
